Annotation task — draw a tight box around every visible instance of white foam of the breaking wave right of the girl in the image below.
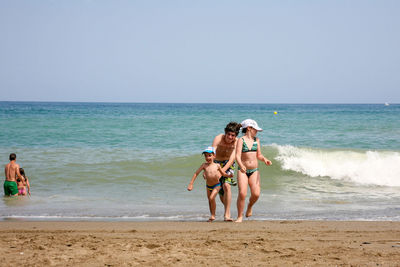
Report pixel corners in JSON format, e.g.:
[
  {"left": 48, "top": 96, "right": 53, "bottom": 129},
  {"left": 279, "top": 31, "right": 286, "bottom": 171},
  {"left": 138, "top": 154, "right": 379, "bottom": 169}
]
[{"left": 274, "top": 145, "right": 400, "bottom": 186}]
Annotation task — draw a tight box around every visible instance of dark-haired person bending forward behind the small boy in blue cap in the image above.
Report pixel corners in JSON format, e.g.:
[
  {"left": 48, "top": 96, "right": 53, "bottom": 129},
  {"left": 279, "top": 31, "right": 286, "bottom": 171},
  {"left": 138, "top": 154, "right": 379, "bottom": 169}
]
[{"left": 212, "top": 122, "right": 240, "bottom": 221}]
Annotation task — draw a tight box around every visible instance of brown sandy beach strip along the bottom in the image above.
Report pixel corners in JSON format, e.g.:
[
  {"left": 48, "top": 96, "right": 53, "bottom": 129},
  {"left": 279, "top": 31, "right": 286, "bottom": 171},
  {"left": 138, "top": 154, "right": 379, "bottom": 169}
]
[{"left": 0, "top": 221, "right": 400, "bottom": 266}]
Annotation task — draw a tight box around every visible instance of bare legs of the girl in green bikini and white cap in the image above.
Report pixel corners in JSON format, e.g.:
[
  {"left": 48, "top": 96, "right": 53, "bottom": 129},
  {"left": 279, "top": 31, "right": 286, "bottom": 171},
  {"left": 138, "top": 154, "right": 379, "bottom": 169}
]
[{"left": 235, "top": 171, "right": 260, "bottom": 222}]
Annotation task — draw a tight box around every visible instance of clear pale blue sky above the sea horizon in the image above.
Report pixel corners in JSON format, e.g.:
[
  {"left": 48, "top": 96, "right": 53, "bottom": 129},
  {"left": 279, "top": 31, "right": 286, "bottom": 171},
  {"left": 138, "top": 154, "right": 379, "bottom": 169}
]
[{"left": 0, "top": 0, "right": 400, "bottom": 103}]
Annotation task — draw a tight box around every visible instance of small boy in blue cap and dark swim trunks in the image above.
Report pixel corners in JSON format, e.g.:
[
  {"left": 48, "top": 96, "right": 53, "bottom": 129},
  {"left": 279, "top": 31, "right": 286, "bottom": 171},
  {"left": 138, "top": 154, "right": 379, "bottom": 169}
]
[{"left": 187, "top": 147, "right": 225, "bottom": 222}]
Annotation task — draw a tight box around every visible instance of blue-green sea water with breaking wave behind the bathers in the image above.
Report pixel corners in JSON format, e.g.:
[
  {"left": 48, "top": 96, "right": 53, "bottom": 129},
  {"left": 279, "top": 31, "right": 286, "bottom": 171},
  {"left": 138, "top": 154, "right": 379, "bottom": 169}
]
[{"left": 0, "top": 102, "right": 400, "bottom": 221}]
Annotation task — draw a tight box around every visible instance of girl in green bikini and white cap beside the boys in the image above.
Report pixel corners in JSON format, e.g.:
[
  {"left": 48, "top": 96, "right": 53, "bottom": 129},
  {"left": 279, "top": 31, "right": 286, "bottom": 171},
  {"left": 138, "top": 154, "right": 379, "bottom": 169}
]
[{"left": 235, "top": 119, "right": 272, "bottom": 222}]
